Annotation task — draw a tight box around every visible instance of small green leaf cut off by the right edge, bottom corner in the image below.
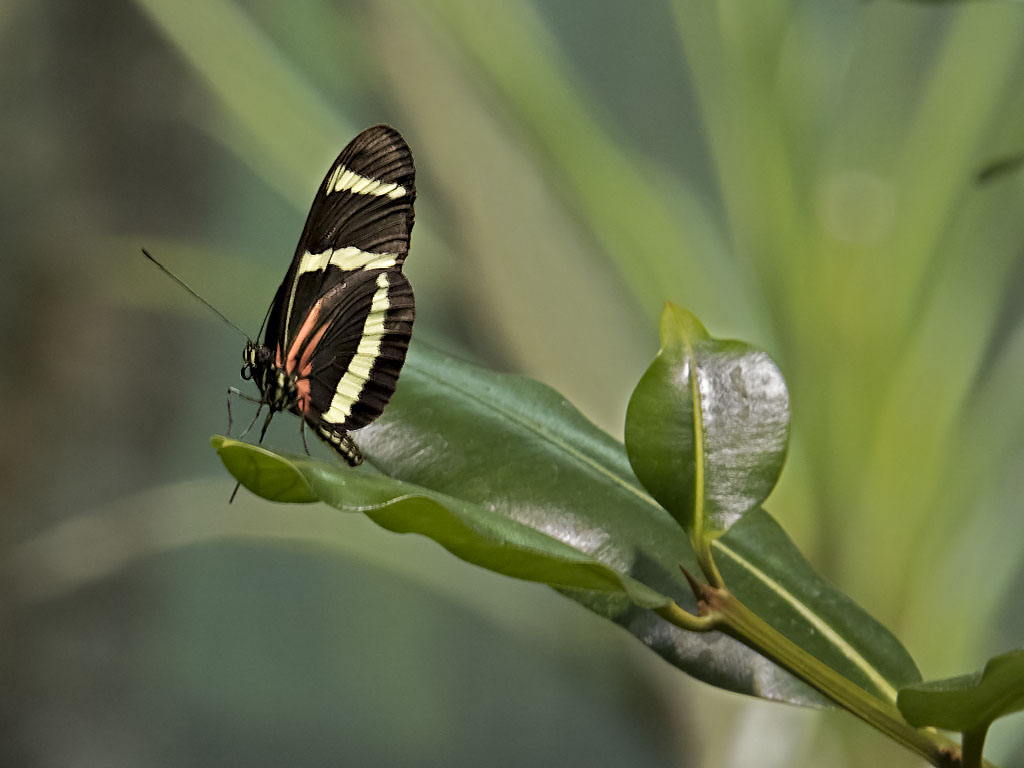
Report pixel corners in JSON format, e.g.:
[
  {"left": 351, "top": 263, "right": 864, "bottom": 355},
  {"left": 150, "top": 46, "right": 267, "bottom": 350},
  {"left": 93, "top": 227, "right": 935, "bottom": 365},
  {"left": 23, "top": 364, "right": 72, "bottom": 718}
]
[{"left": 897, "top": 649, "right": 1024, "bottom": 733}]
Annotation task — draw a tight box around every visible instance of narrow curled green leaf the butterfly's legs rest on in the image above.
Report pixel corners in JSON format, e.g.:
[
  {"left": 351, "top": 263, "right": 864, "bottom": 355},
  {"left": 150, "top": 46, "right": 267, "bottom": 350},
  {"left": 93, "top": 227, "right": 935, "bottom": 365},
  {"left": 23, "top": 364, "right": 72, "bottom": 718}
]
[{"left": 212, "top": 436, "right": 670, "bottom": 608}]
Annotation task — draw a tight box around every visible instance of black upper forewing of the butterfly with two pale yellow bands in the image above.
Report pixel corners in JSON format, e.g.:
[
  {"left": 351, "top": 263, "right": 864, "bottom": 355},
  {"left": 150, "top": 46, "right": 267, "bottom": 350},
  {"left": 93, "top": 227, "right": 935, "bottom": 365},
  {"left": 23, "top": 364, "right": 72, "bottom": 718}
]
[{"left": 263, "top": 125, "right": 416, "bottom": 351}]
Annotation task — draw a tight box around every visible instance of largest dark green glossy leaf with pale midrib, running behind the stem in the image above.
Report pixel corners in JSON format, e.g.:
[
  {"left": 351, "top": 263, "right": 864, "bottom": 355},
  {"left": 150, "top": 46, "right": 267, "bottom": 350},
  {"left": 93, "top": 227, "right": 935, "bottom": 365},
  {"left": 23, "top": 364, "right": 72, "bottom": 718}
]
[{"left": 222, "top": 342, "right": 920, "bottom": 707}]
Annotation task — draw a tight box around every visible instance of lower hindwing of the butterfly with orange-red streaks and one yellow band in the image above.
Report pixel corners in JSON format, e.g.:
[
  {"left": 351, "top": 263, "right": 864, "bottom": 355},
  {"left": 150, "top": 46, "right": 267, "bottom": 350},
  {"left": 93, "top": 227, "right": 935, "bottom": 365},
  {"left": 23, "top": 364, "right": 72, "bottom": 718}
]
[{"left": 288, "top": 269, "right": 416, "bottom": 437}]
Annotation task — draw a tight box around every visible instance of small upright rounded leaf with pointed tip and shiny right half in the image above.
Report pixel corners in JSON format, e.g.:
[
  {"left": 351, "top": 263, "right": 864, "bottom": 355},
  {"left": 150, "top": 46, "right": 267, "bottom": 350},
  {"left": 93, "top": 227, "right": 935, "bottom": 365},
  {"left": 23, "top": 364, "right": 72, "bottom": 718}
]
[{"left": 626, "top": 304, "right": 790, "bottom": 541}]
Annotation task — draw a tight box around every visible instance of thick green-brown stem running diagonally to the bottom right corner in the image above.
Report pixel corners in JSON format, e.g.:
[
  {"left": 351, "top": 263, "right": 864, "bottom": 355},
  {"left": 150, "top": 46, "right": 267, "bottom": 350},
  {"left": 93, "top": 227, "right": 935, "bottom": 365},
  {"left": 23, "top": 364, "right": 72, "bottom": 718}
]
[{"left": 658, "top": 585, "right": 966, "bottom": 768}]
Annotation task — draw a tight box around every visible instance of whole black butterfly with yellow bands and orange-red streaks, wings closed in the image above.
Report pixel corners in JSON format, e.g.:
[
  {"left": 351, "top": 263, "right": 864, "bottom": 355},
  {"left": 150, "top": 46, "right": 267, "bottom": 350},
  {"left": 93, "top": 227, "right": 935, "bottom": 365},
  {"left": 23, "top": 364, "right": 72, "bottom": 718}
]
[{"left": 234, "top": 125, "right": 416, "bottom": 467}]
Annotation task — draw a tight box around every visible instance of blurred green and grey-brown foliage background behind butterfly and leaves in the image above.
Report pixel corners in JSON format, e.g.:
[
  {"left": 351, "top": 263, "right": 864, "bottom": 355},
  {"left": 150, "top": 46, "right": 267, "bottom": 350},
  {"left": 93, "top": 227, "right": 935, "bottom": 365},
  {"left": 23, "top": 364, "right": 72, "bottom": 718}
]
[{"left": 0, "top": 0, "right": 1024, "bottom": 767}]
